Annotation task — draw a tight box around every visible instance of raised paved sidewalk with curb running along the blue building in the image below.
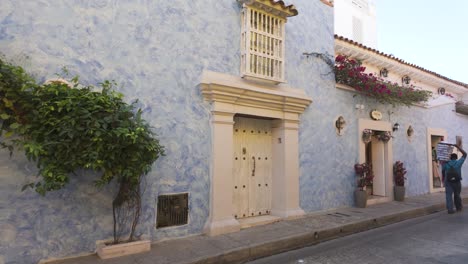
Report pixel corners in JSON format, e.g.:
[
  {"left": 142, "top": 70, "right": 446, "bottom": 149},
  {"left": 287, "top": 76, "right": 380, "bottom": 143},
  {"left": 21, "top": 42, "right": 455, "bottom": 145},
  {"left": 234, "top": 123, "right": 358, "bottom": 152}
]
[{"left": 51, "top": 188, "right": 468, "bottom": 264}]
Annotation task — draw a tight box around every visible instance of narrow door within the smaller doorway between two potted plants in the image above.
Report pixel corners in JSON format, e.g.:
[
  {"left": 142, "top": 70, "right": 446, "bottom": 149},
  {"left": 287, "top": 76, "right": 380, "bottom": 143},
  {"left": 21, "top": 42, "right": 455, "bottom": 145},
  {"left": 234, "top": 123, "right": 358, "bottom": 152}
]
[{"left": 371, "top": 138, "right": 385, "bottom": 196}]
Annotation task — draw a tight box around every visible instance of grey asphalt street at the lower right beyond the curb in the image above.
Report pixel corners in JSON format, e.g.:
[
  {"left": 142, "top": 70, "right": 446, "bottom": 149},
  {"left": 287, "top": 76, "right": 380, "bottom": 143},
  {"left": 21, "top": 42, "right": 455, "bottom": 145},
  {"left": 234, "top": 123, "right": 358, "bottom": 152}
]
[{"left": 248, "top": 210, "right": 468, "bottom": 264}]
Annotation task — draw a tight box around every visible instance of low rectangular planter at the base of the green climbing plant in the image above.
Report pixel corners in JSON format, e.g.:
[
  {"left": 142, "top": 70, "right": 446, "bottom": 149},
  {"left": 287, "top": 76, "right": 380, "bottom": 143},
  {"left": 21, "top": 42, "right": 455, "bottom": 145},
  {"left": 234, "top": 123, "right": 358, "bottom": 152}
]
[{"left": 97, "top": 240, "right": 151, "bottom": 259}]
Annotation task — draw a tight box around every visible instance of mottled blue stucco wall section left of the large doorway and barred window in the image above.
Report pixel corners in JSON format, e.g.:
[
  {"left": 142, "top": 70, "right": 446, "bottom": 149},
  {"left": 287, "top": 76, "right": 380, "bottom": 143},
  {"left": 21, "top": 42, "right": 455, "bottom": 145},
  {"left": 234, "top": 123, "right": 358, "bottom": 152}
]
[{"left": 0, "top": 0, "right": 234, "bottom": 263}]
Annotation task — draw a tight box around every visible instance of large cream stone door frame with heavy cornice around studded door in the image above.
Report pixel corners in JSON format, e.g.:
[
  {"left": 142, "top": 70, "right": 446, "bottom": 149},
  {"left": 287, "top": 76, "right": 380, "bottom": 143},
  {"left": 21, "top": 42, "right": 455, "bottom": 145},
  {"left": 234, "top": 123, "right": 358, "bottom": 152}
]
[{"left": 200, "top": 71, "right": 312, "bottom": 235}]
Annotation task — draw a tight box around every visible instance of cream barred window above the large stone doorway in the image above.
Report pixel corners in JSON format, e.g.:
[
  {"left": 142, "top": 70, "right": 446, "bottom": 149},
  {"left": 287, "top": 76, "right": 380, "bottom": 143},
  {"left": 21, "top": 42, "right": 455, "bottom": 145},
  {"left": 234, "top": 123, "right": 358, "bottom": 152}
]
[{"left": 241, "top": 6, "right": 286, "bottom": 83}]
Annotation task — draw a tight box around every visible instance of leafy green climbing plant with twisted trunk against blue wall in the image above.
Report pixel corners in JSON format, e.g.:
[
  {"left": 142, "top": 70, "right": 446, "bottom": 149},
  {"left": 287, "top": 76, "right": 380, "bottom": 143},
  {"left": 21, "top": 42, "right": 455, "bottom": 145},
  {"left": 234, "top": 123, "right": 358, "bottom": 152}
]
[{"left": 0, "top": 59, "right": 164, "bottom": 243}]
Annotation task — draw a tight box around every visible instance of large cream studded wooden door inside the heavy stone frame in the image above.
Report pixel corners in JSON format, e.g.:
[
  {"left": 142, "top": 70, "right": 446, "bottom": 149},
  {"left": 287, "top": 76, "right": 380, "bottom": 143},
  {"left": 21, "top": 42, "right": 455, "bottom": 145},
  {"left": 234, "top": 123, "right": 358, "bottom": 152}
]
[{"left": 233, "top": 117, "right": 272, "bottom": 218}]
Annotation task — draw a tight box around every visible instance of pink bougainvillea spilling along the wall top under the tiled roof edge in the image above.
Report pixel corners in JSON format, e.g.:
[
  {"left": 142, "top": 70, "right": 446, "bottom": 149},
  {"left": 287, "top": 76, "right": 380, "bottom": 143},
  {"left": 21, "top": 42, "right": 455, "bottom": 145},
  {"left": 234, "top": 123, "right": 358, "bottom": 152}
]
[{"left": 335, "top": 55, "right": 432, "bottom": 106}]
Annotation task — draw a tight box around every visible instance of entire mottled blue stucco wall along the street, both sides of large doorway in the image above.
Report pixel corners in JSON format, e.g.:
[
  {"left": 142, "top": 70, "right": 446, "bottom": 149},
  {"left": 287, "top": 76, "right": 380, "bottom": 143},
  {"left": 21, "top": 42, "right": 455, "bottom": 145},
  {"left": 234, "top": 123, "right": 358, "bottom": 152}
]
[{"left": 0, "top": 0, "right": 468, "bottom": 264}]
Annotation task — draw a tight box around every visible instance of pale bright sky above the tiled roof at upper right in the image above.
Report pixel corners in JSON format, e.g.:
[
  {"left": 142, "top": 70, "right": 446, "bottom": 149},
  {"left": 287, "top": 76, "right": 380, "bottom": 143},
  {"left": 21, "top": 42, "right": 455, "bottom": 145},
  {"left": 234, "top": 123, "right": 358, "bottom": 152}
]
[{"left": 375, "top": 0, "right": 468, "bottom": 84}]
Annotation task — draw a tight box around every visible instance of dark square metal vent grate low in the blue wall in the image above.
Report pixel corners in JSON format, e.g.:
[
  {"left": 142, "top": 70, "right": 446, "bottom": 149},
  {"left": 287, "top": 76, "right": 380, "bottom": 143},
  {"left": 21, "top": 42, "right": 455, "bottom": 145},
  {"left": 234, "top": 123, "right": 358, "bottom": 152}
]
[{"left": 156, "top": 193, "right": 188, "bottom": 228}]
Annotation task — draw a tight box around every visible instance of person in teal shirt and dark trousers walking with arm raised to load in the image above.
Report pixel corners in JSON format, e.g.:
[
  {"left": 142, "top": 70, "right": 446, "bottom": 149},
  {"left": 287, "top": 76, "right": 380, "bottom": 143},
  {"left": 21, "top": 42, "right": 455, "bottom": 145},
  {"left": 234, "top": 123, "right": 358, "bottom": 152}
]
[{"left": 444, "top": 144, "right": 466, "bottom": 214}]
